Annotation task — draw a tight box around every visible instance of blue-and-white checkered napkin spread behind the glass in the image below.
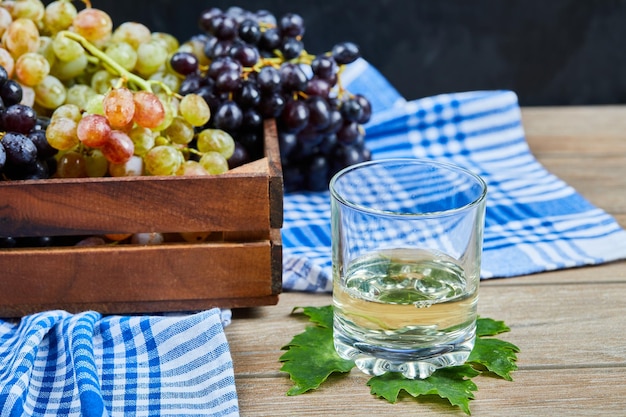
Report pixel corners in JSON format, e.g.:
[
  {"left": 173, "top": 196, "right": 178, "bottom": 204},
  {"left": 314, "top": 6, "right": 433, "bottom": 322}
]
[{"left": 283, "top": 60, "right": 626, "bottom": 292}]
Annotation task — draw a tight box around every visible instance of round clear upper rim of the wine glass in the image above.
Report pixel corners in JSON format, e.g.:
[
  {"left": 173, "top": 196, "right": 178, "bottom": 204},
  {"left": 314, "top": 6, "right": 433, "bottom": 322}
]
[{"left": 328, "top": 158, "right": 487, "bottom": 218}]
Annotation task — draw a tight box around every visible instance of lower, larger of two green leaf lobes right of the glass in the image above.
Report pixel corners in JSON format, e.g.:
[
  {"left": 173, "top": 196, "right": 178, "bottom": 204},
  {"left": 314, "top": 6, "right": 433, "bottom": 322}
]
[{"left": 467, "top": 337, "right": 519, "bottom": 381}]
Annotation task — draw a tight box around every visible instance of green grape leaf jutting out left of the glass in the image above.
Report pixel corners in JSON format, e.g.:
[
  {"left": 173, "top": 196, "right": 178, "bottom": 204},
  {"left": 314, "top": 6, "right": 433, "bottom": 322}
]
[{"left": 279, "top": 307, "right": 354, "bottom": 395}]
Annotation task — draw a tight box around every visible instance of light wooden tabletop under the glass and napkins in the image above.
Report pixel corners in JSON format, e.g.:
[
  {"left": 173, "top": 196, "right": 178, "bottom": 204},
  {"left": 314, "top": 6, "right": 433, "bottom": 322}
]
[{"left": 226, "top": 106, "right": 626, "bottom": 417}]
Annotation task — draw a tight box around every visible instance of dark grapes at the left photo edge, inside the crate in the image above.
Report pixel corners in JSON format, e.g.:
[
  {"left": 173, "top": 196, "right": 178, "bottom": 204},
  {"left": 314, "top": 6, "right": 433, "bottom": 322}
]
[{"left": 0, "top": 66, "right": 57, "bottom": 180}]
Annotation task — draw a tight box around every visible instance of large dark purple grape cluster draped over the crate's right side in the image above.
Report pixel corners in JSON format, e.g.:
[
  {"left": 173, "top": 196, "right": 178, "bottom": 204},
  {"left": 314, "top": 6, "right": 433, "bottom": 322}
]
[{"left": 170, "top": 7, "right": 372, "bottom": 192}]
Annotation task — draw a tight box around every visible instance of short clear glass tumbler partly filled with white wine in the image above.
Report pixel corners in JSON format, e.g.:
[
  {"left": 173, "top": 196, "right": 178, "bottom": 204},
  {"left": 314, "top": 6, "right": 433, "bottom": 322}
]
[{"left": 330, "top": 158, "right": 487, "bottom": 379}]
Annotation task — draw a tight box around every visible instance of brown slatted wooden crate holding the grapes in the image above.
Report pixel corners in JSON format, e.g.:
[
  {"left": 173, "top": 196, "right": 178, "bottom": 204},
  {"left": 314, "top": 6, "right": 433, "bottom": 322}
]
[{"left": 0, "top": 121, "right": 283, "bottom": 317}]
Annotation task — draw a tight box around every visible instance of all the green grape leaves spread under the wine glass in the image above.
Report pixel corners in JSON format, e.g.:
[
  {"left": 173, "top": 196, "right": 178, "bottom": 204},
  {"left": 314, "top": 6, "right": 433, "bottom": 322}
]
[{"left": 279, "top": 306, "right": 519, "bottom": 414}]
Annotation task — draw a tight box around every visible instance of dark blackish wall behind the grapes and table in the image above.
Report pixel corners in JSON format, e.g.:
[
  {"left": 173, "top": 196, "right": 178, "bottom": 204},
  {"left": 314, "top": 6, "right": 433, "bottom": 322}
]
[{"left": 83, "top": 0, "right": 626, "bottom": 106}]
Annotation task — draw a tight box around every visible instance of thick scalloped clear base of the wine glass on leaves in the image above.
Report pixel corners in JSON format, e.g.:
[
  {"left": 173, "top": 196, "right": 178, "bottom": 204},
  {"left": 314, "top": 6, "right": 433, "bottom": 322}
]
[{"left": 334, "top": 326, "right": 476, "bottom": 379}]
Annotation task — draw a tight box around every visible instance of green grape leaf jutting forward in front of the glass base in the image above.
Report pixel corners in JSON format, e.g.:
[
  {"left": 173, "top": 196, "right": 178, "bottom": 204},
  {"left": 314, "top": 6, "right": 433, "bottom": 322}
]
[{"left": 367, "top": 365, "right": 480, "bottom": 414}]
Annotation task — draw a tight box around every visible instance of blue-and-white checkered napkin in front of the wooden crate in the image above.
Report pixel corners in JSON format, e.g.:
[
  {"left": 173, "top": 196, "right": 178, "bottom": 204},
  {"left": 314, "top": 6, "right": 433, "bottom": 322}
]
[{"left": 0, "top": 309, "right": 239, "bottom": 417}]
